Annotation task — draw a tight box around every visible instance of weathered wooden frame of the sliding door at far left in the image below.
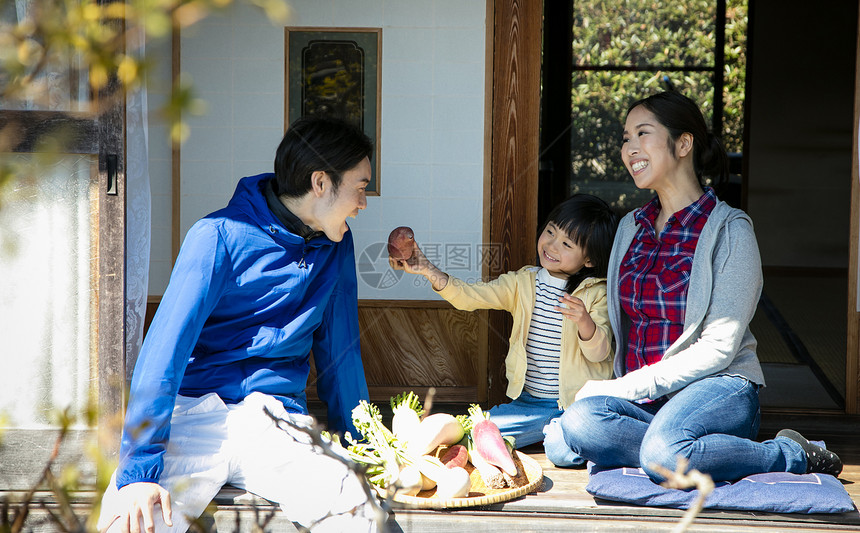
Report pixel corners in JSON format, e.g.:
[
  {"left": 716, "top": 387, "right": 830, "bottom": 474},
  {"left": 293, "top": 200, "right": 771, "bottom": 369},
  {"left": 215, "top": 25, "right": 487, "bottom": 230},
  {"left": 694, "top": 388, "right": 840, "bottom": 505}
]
[{"left": 0, "top": 45, "right": 126, "bottom": 490}]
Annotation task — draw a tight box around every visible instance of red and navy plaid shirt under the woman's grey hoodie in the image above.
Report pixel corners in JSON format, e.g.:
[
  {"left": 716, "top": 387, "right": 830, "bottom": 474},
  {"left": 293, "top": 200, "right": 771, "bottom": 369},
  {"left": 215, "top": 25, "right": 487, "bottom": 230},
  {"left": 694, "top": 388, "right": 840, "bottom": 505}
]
[{"left": 619, "top": 188, "right": 717, "bottom": 372}]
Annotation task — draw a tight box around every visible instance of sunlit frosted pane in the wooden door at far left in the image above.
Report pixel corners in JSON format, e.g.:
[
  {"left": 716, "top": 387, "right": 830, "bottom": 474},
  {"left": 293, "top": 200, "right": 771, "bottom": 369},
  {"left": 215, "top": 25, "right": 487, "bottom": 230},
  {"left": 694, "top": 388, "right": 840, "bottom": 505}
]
[{"left": 0, "top": 154, "right": 98, "bottom": 429}]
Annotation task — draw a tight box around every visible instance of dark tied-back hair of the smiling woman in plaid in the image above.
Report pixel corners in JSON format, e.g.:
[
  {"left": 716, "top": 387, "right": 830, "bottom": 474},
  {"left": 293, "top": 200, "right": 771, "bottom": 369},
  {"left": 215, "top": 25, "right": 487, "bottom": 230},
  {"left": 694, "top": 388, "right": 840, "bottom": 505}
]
[{"left": 627, "top": 91, "right": 729, "bottom": 192}]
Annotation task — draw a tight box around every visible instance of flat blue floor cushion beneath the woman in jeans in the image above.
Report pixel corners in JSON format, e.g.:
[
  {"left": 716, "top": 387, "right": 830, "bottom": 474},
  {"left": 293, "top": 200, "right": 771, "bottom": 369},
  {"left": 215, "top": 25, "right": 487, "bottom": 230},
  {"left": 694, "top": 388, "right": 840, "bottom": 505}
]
[{"left": 585, "top": 463, "right": 854, "bottom": 513}]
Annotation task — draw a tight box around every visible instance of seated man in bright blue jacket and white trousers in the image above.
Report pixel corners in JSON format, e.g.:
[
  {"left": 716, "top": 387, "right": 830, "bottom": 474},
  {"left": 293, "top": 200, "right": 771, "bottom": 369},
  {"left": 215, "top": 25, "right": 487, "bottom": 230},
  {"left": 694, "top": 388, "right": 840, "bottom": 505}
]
[{"left": 99, "top": 117, "right": 375, "bottom": 532}]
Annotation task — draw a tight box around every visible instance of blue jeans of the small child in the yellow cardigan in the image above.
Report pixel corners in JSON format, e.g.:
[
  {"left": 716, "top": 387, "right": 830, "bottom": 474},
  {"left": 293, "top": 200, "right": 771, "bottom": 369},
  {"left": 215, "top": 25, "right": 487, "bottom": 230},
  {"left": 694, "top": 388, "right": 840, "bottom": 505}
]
[{"left": 490, "top": 391, "right": 585, "bottom": 466}]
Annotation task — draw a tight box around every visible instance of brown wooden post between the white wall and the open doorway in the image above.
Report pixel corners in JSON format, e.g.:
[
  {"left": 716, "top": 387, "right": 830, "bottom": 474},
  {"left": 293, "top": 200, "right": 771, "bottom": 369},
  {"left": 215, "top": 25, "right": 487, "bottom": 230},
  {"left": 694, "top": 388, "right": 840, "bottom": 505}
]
[{"left": 487, "top": 0, "right": 543, "bottom": 405}]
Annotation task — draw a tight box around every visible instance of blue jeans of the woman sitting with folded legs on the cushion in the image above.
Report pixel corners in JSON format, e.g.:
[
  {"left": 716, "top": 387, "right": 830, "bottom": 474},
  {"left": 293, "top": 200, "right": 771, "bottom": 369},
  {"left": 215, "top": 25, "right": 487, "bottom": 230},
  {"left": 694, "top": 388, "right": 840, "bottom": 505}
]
[{"left": 561, "top": 375, "right": 806, "bottom": 482}]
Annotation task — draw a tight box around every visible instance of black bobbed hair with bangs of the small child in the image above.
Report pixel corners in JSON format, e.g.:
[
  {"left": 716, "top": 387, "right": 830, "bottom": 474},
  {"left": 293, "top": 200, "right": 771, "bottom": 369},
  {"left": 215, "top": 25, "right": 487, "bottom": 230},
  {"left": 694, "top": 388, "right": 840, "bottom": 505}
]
[{"left": 538, "top": 194, "right": 619, "bottom": 293}]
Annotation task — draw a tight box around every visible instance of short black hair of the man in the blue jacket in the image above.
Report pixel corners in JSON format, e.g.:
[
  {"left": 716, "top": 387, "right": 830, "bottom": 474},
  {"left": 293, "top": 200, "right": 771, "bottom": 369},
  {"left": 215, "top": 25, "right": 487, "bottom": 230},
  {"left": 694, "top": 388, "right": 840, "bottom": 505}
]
[{"left": 274, "top": 116, "right": 373, "bottom": 198}]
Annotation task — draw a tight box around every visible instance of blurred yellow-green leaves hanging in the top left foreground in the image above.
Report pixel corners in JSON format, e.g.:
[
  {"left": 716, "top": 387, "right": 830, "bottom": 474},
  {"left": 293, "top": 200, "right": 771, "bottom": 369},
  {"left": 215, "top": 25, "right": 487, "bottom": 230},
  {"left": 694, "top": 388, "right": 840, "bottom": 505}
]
[{"left": 0, "top": 0, "right": 289, "bottom": 195}]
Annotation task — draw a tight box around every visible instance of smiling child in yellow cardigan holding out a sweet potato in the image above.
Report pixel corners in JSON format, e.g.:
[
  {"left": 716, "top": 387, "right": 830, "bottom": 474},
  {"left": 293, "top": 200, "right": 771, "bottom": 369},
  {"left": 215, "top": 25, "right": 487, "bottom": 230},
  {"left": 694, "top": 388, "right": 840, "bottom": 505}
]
[{"left": 389, "top": 194, "right": 618, "bottom": 466}]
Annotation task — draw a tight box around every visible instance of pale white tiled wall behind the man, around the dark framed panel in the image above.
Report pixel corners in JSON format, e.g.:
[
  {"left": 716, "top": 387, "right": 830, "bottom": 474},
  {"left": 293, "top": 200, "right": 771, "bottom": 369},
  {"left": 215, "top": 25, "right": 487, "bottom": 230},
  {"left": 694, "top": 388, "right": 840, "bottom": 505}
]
[{"left": 144, "top": 0, "right": 486, "bottom": 299}]
